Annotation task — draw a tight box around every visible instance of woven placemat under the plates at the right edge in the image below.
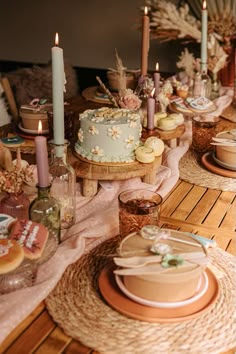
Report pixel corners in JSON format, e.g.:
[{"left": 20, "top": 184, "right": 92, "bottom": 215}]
[{"left": 179, "top": 150, "right": 236, "bottom": 192}]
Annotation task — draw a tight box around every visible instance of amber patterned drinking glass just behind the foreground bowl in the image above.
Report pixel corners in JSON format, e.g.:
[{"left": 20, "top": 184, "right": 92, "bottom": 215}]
[{"left": 118, "top": 189, "right": 162, "bottom": 237}]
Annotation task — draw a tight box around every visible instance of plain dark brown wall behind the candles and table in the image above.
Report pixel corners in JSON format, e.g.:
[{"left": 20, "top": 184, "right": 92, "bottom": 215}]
[{"left": 0, "top": 0, "right": 199, "bottom": 72}]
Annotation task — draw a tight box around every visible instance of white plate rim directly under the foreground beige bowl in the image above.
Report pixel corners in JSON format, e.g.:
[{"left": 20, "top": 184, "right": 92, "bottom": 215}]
[{"left": 115, "top": 272, "right": 209, "bottom": 309}]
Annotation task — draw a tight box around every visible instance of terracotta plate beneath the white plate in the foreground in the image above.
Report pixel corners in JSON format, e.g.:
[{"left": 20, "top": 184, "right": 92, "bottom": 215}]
[{"left": 98, "top": 265, "right": 219, "bottom": 323}]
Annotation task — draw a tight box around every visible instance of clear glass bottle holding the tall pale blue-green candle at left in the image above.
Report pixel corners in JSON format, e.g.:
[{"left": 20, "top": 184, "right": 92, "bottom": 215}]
[{"left": 49, "top": 140, "right": 76, "bottom": 229}]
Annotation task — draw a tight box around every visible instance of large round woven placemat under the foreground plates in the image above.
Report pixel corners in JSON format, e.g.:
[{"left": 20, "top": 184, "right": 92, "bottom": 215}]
[{"left": 46, "top": 237, "right": 236, "bottom": 354}]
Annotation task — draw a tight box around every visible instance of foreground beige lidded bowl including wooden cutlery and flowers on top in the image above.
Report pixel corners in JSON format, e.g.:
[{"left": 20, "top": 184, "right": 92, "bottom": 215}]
[{"left": 114, "top": 225, "right": 209, "bottom": 302}]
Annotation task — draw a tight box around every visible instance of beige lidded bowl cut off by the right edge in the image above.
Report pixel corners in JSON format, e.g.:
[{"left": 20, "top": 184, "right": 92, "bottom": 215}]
[{"left": 216, "top": 131, "right": 236, "bottom": 168}]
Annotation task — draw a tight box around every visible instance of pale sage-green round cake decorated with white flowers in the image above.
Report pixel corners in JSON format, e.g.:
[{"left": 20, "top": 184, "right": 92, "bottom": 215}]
[{"left": 75, "top": 107, "right": 142, "bottom": 163}]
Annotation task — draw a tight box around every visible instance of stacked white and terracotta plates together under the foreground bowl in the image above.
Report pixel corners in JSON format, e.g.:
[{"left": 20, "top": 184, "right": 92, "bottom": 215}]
[{"left": 98, "top": 264, "right": 219, "bottom": 323}]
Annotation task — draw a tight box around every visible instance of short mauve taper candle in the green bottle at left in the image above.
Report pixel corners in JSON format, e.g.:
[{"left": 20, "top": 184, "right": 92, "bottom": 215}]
[{"left": 35, "top": 136, "right": 49, "bottom": 187}]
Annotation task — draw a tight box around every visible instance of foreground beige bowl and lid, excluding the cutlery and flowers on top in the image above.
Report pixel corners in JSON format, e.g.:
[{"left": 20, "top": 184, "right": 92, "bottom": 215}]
[{"left": 119, "top": 230, "right": 207, "bottom": 302}]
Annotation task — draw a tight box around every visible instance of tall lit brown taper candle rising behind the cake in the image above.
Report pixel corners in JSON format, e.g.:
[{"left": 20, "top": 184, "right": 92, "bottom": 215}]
[{"left": 141, "top": 6, "right": 150, "bottom": 76}]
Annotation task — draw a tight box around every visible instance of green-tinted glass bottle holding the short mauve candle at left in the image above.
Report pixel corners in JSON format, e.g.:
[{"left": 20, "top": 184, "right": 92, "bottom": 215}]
[{"left": 29, "top": 185, "right": 60, "bottom": 245}]
